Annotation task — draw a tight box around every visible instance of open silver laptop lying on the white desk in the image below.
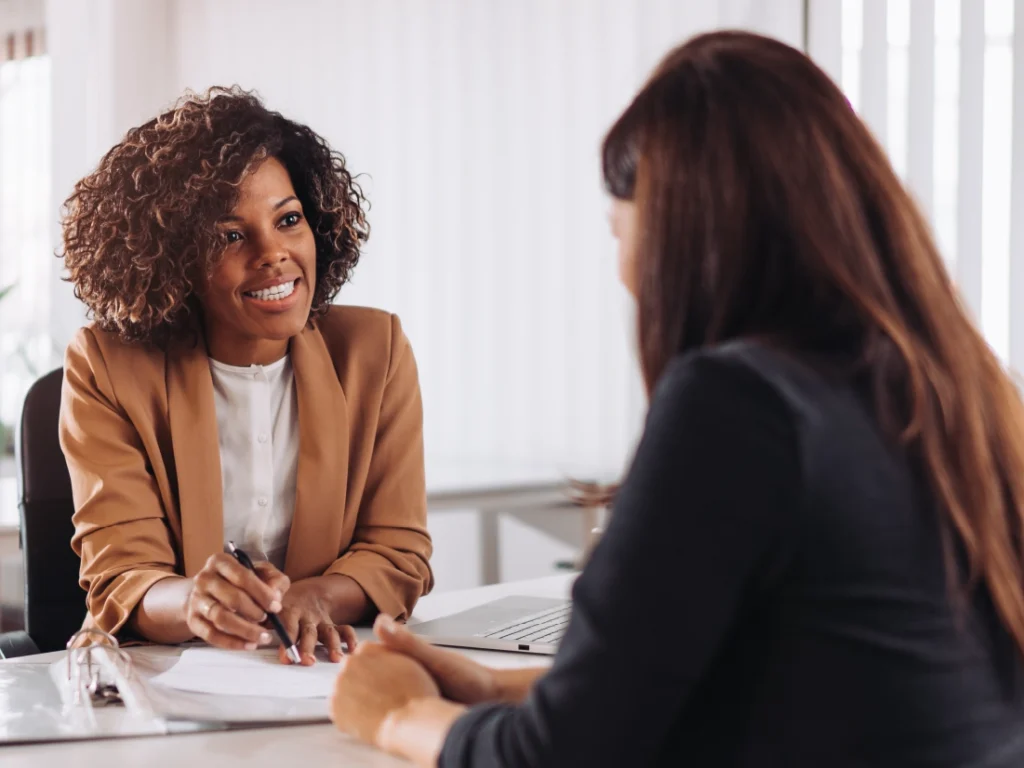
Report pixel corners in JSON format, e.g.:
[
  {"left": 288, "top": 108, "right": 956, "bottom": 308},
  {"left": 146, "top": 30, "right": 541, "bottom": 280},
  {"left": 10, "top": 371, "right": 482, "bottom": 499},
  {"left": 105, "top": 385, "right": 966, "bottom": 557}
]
[{"left": 409, "top": 596, "right": 572, "bottom": 655}]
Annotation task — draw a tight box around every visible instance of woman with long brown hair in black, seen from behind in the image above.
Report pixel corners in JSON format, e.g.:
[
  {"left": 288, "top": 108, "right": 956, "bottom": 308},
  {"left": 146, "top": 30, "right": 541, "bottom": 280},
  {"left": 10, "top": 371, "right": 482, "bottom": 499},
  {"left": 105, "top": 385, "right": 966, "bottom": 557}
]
[{"left": 325, "top": 28, "right": 1024, "bottom": 768}]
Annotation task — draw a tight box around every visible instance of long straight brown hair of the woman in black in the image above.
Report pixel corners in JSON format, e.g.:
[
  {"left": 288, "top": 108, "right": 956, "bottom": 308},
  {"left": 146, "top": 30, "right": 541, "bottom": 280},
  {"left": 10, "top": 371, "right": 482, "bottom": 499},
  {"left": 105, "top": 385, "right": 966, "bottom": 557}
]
[{"left": 603, "top": 32, "right": 1024, "bottom": 652}]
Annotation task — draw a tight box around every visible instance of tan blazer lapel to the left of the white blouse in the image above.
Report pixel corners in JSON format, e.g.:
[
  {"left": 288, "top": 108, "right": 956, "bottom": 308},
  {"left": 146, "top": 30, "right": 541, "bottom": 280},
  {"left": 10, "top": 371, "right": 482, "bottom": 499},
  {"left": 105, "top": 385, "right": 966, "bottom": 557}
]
[{"left": 167, "top": 334, "right": 224, "bottom": 577}]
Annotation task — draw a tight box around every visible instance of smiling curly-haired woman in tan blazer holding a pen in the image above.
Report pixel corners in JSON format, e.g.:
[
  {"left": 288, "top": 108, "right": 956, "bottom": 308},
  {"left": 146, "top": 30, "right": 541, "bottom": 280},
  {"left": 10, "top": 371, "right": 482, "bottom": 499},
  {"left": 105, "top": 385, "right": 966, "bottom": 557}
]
[{"left": 60, "top": 82, "right": 432, "bottom": 664}]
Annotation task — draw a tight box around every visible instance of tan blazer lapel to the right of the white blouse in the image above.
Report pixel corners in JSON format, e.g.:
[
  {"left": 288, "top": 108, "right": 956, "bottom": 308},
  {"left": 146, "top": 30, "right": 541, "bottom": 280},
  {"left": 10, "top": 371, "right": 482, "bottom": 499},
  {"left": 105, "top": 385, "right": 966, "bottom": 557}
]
[{"left": 285, "top": 325, "right": 348, "bottom": 581}]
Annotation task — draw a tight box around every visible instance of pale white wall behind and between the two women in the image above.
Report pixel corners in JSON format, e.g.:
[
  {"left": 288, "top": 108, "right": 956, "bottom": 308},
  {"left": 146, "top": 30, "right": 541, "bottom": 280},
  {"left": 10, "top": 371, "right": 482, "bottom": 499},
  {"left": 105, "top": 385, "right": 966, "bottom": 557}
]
[{"left": 47, "top": 0, "right": 803, "bottom": 586}]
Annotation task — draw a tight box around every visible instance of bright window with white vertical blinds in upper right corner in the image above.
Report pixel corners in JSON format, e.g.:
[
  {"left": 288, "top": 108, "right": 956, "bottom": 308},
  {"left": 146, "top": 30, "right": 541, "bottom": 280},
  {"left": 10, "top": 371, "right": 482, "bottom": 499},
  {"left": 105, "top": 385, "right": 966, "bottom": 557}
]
[{"left": 808, "top": 0, "right": 1024, "bottom": 371}]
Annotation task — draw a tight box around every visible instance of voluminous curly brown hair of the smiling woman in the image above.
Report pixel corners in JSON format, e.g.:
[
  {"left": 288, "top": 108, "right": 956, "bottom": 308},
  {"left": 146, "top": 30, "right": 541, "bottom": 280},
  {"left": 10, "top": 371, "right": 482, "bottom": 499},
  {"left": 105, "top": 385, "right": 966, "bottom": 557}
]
[{"left": 58, "top": 86, "right": 370, "bottom": 343}]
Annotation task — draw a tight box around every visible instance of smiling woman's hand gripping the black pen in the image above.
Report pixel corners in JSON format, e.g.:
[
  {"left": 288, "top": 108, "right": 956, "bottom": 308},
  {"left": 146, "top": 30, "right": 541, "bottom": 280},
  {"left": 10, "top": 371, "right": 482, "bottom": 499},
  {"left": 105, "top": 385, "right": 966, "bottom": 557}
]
[{"left": 185, "top": 553, "right": 291, "bottom": 650}]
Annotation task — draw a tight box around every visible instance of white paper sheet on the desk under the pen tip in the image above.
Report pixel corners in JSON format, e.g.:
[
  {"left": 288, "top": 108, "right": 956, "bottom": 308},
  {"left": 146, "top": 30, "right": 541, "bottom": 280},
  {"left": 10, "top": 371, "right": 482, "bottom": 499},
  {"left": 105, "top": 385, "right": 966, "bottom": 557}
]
[{"left": 152, "top": 648, "right": 339, "bottom": 698}]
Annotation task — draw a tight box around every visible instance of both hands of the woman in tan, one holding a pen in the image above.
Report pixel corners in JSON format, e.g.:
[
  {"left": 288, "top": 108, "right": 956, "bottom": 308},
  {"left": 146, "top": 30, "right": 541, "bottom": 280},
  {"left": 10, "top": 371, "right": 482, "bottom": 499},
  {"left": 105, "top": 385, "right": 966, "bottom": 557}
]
[{"left": 185, "top": 553, "right": 356, "bottom": 666}]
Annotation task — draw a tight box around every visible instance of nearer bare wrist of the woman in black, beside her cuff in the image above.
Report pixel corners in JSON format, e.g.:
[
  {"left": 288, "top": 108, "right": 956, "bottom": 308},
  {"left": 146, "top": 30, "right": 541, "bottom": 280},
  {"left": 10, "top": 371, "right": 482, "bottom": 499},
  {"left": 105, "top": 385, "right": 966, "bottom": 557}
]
[{"left": 375, "top": 698, "right": 466, "bottom": 768}]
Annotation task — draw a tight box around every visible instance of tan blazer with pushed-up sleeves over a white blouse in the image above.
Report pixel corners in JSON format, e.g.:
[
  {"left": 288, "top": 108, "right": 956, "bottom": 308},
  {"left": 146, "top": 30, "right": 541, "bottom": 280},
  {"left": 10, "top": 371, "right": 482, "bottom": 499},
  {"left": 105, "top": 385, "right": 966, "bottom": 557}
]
[{"left": 60, "top": 306, "right": 433, "bottom": 633}]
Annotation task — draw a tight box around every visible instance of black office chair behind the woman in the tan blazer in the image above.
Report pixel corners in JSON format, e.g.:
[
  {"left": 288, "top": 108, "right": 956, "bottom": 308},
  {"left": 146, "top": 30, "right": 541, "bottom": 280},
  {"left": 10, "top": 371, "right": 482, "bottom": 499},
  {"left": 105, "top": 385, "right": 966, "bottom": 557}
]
[{"left": 0, "top": 369, "right": 86, "bottom": 657}]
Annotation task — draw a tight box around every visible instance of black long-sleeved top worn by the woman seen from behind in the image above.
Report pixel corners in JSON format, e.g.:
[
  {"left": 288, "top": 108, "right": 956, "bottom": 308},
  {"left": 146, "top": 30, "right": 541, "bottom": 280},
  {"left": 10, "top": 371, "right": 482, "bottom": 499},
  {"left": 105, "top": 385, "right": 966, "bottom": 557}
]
[{"left": 440, "top": 343, "right": 1024, "bottom": 768}]
